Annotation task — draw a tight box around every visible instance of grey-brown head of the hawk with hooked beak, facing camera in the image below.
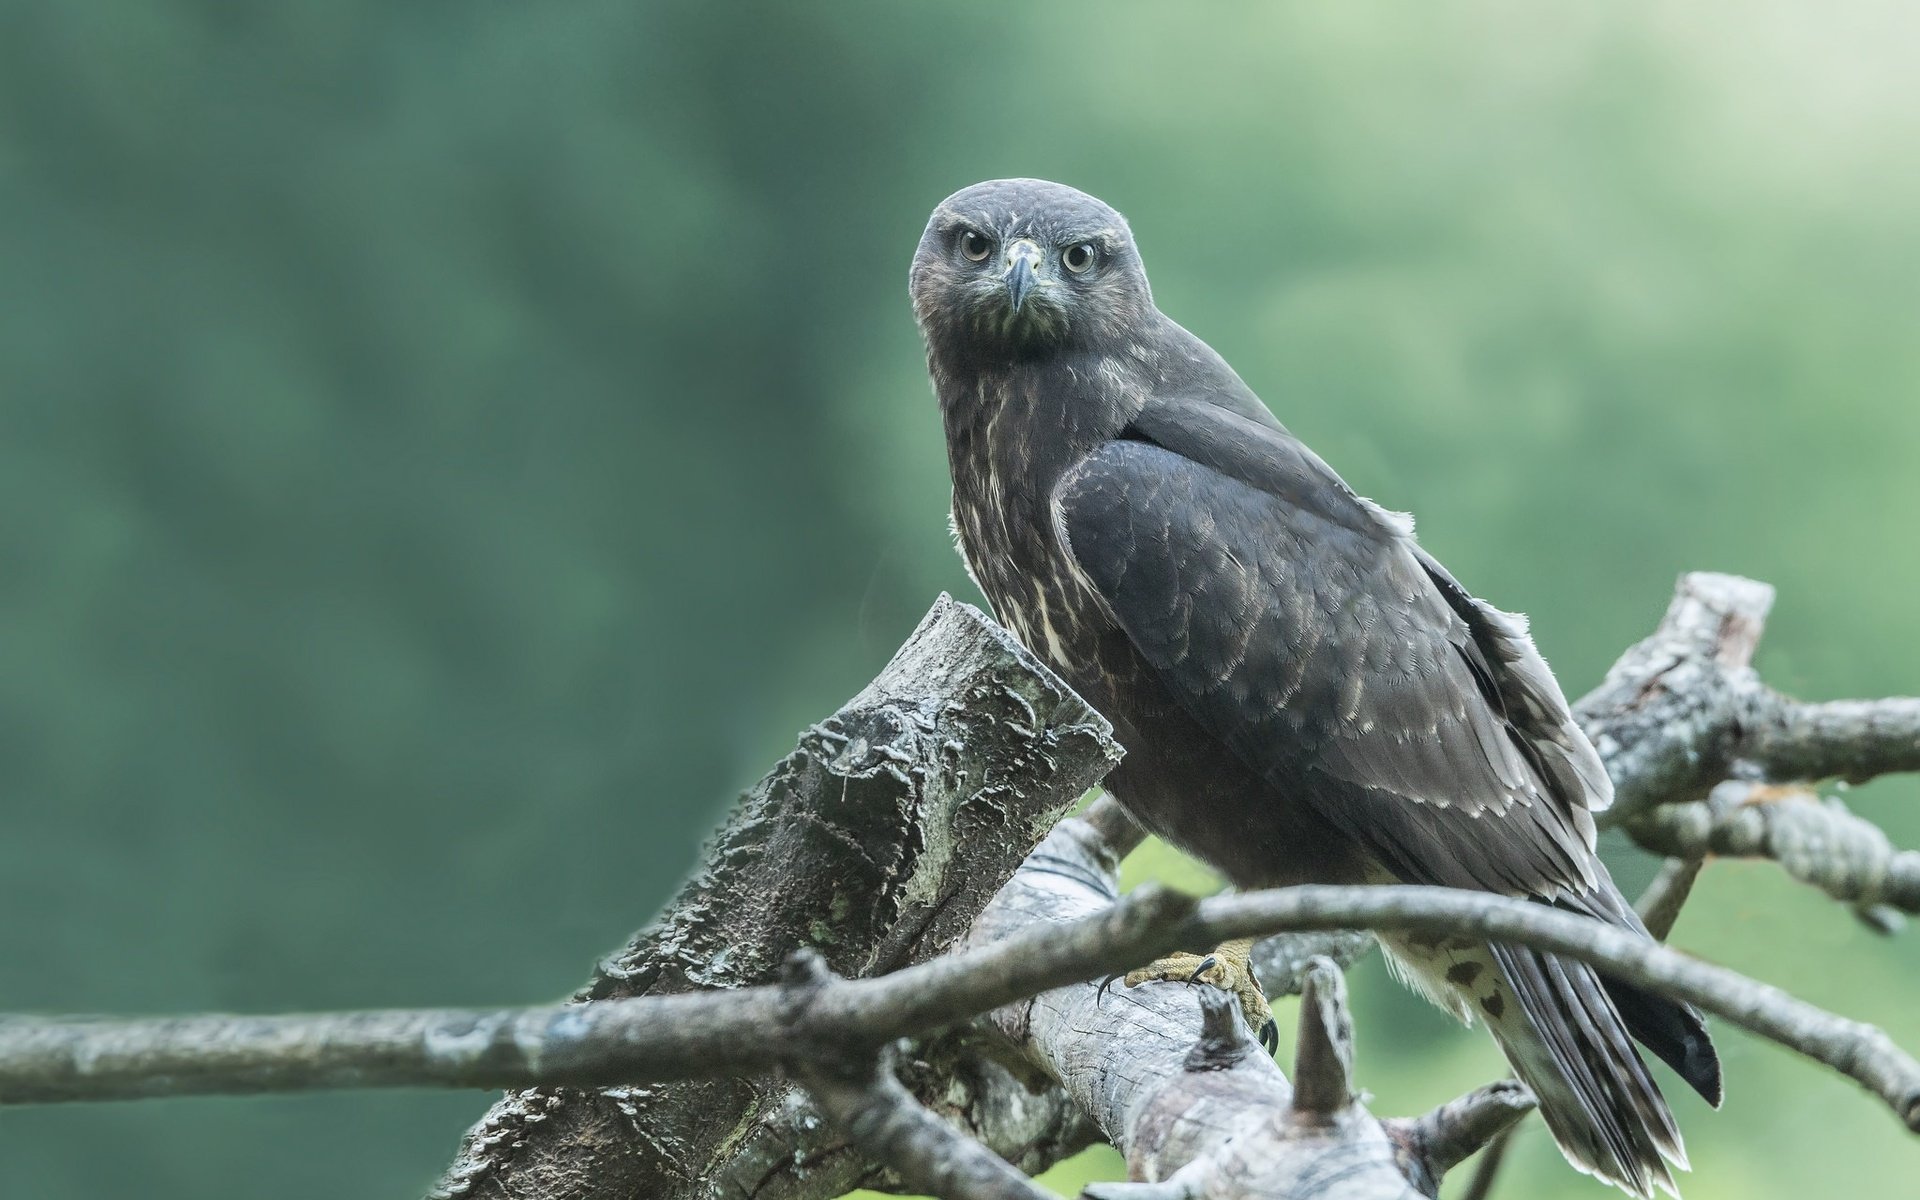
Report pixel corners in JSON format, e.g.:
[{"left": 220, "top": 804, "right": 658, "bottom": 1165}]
[{"left": 908, "top": 179, "right": 1154, "bottom": 357}]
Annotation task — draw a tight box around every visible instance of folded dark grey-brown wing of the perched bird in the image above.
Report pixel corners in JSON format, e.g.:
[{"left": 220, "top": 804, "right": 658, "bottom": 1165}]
[{"left": 1054, "top": 403, "right": 1611, "bottom": 899}]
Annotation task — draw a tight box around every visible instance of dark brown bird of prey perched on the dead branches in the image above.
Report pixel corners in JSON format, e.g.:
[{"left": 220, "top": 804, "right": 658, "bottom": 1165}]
[{"left": 910, "top": 179, "right": 1720, "bottom": 1196}]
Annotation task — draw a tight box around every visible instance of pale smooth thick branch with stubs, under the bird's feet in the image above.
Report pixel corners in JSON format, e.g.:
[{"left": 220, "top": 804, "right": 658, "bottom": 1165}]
[{"left": 979, "top": 820, "right": 1524, "bottom": 1200}]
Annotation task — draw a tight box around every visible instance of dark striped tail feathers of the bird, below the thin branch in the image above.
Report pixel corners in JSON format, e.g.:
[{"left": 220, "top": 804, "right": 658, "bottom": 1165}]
[{"left": 1480, "top": 945, "right": 1718, "bottom": 1196}]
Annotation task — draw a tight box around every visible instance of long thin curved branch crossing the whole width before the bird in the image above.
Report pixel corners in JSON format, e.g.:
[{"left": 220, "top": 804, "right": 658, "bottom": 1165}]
[{"left": 0, "top": 887, "right": 1920, "bottom": 1131}]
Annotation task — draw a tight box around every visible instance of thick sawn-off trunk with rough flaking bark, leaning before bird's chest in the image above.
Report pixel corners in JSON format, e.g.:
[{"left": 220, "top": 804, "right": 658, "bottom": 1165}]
[{"left": 432, "top": 597, "right": 1119, "bottom": 1200}]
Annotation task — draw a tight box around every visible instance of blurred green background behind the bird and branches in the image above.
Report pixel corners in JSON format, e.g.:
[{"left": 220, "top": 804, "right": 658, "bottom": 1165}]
[{"left": 0, "top": 0, "right": 1920, "bottom": 1200}]
